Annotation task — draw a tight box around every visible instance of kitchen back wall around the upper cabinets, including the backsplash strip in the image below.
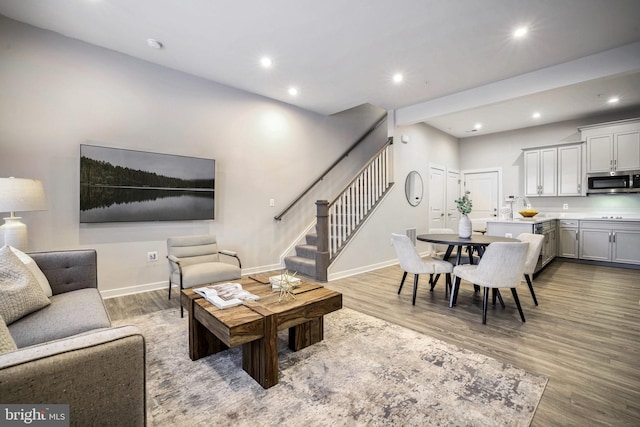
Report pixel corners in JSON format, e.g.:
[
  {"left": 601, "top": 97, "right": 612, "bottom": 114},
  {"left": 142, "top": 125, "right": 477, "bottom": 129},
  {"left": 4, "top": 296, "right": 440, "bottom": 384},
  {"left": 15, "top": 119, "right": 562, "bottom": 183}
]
[{"left": 460, "top": 110, "right": 640, "bottom": 215}]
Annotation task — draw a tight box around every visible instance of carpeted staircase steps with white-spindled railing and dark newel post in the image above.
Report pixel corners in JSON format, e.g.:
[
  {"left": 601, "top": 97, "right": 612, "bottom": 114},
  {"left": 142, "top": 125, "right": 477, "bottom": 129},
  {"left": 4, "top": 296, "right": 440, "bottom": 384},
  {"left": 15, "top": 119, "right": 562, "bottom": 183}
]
[{"left": 284, "top": 138, "right": 393, "bottom": 281}]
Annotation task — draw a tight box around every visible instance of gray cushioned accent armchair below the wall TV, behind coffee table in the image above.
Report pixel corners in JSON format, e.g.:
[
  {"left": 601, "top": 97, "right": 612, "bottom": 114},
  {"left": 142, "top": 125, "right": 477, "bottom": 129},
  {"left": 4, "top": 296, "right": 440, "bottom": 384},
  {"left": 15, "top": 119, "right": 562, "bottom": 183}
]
[{"left": 167, "top": 234, "right": 242, "bottom": 317}]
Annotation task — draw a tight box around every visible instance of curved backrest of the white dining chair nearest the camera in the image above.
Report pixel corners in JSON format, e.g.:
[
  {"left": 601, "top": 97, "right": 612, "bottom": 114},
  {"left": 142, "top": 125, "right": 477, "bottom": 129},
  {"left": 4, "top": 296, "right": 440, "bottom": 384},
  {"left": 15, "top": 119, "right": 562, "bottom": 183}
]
[{"left": 474, "top": 242, "right": 529, "bottom": 288}]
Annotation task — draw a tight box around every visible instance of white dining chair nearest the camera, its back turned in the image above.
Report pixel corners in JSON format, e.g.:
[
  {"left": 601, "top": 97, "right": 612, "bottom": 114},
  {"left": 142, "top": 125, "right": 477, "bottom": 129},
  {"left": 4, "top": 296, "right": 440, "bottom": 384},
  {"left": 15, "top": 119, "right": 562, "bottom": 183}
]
[{"left": 450, "top": 242, "right": 529, "bottom": 324}]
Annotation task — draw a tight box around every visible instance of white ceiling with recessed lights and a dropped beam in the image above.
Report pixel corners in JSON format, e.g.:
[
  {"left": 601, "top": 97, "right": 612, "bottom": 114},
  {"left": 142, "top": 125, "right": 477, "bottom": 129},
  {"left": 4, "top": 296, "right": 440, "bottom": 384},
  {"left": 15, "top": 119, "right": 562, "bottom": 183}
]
[{"left": 0, "top": 0, "right": 640, "bottom": 137}]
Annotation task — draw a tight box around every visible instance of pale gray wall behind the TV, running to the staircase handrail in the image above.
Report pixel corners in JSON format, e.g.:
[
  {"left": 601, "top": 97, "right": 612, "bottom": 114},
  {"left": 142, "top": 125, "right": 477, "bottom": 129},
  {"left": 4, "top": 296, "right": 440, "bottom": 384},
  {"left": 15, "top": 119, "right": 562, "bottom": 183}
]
[{"left": 0, "top": 17, "right": 386, "bottom": 296}]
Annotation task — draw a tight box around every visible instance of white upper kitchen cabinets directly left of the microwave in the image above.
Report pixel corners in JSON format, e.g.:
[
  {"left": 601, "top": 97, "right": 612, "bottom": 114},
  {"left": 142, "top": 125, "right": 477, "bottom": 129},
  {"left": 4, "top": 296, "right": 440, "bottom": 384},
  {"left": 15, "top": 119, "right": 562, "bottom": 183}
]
[{"left": 523, "top": 143, "right": 584, "bottom": 197}]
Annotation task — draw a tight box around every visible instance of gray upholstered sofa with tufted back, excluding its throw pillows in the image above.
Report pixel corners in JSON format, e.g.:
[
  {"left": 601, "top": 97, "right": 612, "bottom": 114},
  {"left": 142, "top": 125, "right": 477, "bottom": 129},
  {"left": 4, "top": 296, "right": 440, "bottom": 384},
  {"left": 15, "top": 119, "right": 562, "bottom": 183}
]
[{"left": 0, "top": 250, "right": 147, "bottom": 426}]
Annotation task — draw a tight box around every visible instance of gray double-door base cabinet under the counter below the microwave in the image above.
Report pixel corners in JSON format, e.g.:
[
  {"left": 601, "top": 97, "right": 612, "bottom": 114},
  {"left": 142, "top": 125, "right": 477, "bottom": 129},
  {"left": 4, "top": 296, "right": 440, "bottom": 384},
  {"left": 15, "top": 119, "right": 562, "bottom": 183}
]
[{"left": 579, "top": 221, "right": 640, "bottom": 265}]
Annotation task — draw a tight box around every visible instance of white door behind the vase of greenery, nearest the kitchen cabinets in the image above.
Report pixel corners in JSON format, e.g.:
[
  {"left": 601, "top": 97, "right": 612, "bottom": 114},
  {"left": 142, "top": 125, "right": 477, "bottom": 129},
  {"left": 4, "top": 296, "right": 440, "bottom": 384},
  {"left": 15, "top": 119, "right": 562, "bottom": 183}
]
[{"left": 462, "top": 169, "right": 501, "bottom": 220}]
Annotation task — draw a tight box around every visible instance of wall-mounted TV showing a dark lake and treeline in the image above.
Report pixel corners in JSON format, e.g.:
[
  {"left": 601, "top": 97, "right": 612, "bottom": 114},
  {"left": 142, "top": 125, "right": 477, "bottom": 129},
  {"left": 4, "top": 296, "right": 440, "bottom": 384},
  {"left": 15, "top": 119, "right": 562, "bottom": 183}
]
[{"left": 80, "top": 144, "right": 216, "bottom": 223}]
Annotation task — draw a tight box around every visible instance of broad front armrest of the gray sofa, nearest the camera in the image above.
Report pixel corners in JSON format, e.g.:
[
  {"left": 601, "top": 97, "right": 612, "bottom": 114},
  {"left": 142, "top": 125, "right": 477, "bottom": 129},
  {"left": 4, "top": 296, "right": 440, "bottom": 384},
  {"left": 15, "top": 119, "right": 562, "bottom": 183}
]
[{"left": 0, "top": 326, "right": 146, "bottom": 426}]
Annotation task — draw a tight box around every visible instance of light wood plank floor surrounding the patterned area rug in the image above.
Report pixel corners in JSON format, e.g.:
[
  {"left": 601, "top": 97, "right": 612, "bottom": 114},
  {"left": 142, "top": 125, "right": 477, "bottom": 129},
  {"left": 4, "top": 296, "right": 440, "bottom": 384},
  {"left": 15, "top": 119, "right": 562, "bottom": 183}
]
[{"left": 105, "top": 260, "right": 640, "bottom": 426}]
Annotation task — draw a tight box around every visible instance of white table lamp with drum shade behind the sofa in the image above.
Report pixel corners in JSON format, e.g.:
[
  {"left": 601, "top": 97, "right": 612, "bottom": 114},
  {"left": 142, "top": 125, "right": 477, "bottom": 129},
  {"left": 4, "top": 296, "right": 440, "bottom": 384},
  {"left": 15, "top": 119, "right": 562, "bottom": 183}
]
[{"left": 0, "top": 177, "right": 47, "bottom": 251}]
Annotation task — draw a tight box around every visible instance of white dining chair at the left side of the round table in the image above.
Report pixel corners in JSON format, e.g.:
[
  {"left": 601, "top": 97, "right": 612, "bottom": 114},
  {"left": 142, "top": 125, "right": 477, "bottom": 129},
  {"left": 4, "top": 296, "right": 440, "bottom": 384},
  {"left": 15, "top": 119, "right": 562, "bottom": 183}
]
[{"left": 391, "top": 233, "right": 453, "bottom": 305}]
